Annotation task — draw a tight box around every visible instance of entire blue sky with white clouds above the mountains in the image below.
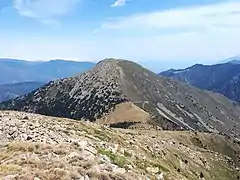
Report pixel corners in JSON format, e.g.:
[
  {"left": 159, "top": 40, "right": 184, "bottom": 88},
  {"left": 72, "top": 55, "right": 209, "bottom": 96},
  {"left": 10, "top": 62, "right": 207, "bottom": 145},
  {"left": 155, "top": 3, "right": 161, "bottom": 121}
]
[{"left": 0, "top": 0, "right": 240, "bottom": 70}]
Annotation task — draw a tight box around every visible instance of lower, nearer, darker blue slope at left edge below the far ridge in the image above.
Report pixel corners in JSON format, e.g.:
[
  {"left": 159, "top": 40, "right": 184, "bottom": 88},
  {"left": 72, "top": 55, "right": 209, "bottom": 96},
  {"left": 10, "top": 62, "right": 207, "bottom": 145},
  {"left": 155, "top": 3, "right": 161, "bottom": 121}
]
[{"left": 0, "top": 82, "right": 44, "bottom": 102}]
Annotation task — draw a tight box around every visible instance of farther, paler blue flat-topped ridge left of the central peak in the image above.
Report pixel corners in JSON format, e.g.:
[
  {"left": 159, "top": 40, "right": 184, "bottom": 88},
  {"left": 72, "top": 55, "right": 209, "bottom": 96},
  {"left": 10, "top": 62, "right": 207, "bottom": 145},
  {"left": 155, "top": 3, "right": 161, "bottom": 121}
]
[{"left": 0, "top": 59, "right": 95, "bottom": 84}]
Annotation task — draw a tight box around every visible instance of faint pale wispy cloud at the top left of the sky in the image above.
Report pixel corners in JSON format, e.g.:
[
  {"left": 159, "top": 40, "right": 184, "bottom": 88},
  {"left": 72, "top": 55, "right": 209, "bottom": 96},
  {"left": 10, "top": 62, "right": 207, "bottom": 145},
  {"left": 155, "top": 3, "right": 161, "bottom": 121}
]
[{"left": 13, "top": 0, "right": 80, "bottom": 24}]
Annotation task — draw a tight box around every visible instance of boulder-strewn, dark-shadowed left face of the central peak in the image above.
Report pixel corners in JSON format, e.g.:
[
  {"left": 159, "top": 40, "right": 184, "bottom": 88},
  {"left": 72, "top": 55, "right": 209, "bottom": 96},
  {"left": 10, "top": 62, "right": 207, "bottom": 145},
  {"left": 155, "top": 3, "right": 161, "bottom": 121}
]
[{"left": 3, "top": 62, "right": 127, "bottom": 121}]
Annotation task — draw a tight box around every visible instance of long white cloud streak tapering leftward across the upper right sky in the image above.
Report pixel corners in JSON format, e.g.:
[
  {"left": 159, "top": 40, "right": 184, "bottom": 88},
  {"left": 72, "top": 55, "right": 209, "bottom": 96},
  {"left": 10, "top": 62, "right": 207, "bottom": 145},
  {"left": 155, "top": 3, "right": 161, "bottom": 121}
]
[{"left": 102, "top": 2, "right": 240, "bottom": 32}]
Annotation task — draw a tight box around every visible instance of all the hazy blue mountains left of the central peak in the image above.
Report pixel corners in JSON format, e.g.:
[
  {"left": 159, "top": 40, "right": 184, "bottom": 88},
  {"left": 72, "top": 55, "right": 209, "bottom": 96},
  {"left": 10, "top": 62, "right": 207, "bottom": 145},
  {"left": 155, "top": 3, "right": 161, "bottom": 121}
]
[{"left": 0, "top": 59, "right": 95, "bottom": 102}]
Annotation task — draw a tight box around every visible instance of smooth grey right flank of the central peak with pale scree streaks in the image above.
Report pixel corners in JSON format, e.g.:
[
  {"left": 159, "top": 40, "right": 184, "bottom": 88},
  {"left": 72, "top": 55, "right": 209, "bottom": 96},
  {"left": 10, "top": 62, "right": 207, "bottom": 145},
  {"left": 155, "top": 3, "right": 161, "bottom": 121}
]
[{"left": 118, "top": 61, "right": 240, "bottom": 137}]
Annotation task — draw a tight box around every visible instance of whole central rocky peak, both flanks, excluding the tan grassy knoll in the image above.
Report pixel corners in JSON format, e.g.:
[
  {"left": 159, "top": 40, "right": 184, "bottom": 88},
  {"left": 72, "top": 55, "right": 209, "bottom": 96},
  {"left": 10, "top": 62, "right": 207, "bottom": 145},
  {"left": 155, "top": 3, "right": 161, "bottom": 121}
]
[{"left": 0, "top": 59, "right": 240, "bottom": 137}]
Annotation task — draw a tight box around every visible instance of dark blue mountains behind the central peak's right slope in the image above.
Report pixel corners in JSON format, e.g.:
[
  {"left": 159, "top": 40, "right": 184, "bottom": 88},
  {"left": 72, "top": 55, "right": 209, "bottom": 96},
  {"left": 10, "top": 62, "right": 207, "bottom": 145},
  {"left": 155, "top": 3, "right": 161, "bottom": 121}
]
[{"left": 160, "top": 57, "right": 240, "bottom": 102}]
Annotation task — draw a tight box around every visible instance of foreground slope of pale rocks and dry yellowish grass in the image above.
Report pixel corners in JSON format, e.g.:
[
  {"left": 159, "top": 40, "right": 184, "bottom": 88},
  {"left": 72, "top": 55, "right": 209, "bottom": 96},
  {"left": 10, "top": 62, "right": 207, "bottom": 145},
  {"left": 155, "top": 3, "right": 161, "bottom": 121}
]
[{"left": 0, "top": 111, "right": 240, "bottom": 180}]
